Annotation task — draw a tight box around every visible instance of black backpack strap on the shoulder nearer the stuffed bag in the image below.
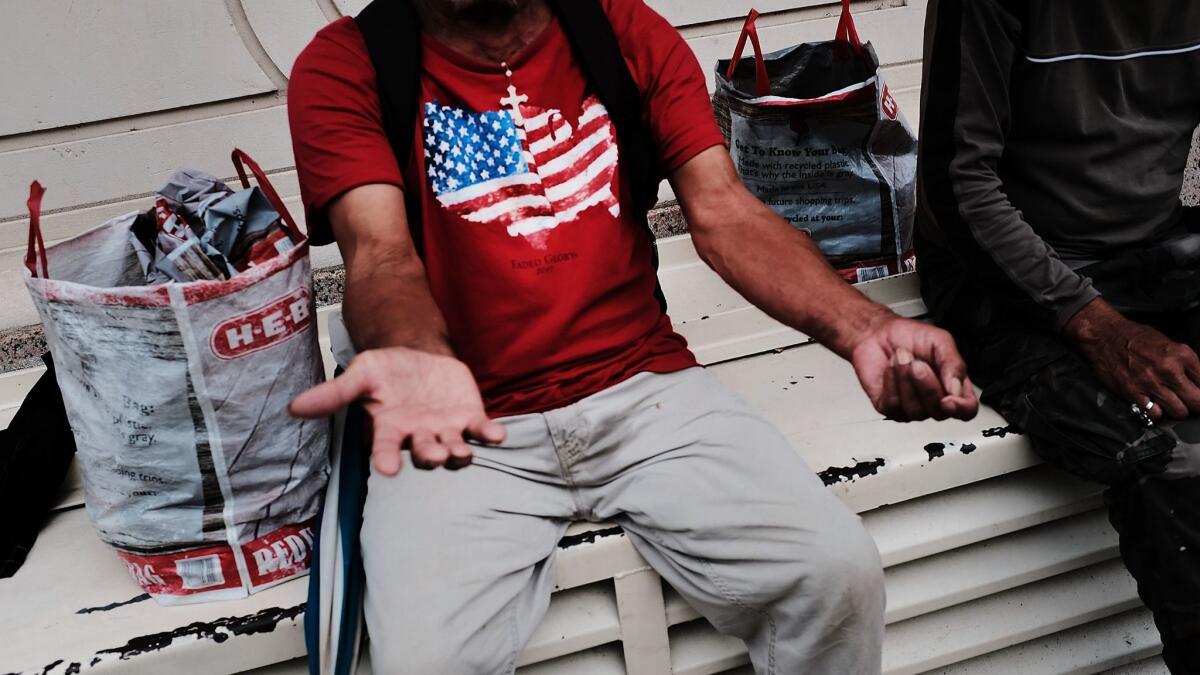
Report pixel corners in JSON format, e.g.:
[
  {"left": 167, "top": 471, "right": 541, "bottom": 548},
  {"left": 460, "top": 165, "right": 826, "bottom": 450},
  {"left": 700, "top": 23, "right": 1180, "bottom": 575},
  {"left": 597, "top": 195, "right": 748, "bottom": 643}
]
[{"left": 354, "top": 0, "right": 425, "bottom": 258}]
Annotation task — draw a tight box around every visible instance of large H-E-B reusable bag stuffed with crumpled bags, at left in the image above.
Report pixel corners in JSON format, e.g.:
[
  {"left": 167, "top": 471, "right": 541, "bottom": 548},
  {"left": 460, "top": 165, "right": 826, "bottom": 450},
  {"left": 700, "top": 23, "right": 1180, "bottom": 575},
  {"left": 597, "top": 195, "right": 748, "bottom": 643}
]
[{"left": 24, "top": 150, "right": 330, "bottom": 604}]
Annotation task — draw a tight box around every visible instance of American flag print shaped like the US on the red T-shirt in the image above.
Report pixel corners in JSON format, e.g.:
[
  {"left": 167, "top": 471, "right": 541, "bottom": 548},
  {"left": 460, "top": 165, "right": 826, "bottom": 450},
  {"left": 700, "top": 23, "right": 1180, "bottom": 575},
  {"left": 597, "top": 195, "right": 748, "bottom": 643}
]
[{"left": 422, "top": 88, "right": 620, "bottom": 247}]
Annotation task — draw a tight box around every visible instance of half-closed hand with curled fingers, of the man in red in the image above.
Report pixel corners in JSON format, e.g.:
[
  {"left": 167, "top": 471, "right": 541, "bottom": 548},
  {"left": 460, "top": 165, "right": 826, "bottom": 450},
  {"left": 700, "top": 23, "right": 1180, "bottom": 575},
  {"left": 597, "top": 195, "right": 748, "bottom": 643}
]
[{"left": 851, "top": 316, "right": 979, "bottom": 422}]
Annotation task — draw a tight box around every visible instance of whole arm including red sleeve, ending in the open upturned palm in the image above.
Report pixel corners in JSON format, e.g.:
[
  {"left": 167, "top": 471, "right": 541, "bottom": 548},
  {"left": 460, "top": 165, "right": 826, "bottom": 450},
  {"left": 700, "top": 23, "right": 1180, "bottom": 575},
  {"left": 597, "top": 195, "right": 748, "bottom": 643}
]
[{"left": 288, "top": 22, "right": 504, "bottom": 468}]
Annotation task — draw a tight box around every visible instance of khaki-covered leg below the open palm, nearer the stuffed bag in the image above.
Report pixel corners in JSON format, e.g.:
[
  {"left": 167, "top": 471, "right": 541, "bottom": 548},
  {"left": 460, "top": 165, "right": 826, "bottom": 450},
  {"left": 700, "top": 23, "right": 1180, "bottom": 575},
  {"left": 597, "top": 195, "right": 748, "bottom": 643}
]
[{"left": 361, "top": 416, "right": 574, "bottom": 675}]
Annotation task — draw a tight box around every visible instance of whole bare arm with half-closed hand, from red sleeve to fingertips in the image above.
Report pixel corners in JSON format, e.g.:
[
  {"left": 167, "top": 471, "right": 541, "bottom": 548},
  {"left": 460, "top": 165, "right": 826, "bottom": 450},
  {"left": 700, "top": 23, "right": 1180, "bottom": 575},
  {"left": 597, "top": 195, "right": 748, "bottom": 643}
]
[{"left": 671, "top": 148, "right": 978, "bottom": 420}]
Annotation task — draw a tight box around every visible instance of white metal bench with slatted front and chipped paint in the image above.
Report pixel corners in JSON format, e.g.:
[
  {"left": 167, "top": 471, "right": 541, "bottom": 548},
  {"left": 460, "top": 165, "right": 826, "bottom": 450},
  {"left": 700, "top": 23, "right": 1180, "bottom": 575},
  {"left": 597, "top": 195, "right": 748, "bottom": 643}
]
[{"left": 0, "top": 237, "right": 1165, "bottom": 675}]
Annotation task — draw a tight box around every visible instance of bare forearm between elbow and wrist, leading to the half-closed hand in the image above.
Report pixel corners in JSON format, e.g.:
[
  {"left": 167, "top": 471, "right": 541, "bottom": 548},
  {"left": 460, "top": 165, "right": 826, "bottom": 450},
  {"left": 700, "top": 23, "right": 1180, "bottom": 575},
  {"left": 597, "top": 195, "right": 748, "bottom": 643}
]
[{"left": 692, "top": 193, "right": 892, "bottom": 358}]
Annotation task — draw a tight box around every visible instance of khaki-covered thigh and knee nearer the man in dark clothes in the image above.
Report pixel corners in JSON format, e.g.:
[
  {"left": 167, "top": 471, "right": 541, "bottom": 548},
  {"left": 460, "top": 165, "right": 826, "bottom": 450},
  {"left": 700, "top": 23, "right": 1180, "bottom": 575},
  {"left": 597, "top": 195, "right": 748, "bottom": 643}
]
[{"left": 593, "top": 370, "right": 883, "bottom": 634}]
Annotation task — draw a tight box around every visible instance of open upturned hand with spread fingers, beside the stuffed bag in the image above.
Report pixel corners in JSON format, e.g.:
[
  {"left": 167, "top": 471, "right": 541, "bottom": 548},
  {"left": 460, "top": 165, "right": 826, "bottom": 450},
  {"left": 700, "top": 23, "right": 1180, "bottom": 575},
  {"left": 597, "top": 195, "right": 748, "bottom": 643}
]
[{"left": 288, "top": 347, "right": 505, "bottom": 476}]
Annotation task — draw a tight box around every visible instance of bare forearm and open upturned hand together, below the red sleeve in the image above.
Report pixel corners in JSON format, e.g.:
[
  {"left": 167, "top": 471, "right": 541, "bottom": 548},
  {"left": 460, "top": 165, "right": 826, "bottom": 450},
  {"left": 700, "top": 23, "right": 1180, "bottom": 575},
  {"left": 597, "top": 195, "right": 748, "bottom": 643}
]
[{"left": 290, "top": 185, "right": 504, "bottom": 476}]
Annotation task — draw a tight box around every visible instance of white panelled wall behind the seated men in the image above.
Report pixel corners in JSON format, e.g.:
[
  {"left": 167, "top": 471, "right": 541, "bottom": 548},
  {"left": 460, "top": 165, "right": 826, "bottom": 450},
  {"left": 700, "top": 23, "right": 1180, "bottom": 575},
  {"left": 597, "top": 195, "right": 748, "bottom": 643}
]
[{"left": 0, "top": 0, "right": 925, "bottom": 329}]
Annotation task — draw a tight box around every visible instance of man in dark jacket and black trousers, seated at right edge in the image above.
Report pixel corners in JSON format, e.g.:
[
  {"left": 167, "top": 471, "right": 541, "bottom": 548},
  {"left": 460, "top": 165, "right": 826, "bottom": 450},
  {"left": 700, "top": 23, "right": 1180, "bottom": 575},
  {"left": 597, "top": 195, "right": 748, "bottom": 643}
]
[{"left": 917, "top": 0, "right": 1200, "bottom": 673}]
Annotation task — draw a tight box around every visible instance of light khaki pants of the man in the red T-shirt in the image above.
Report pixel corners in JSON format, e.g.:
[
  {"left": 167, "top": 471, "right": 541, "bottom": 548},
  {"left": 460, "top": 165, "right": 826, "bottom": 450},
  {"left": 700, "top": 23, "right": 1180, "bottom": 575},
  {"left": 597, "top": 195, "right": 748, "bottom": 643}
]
[{"left": 352, "top": 368, "right": 884, "bottom": 675}]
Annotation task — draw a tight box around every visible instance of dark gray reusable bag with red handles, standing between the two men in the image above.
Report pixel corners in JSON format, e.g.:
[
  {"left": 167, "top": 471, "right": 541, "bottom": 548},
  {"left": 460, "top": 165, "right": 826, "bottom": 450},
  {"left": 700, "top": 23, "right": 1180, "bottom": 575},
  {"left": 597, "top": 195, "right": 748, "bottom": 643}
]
[{"left": 713, "top": 0, "right": 917, "bottom": 281}]
